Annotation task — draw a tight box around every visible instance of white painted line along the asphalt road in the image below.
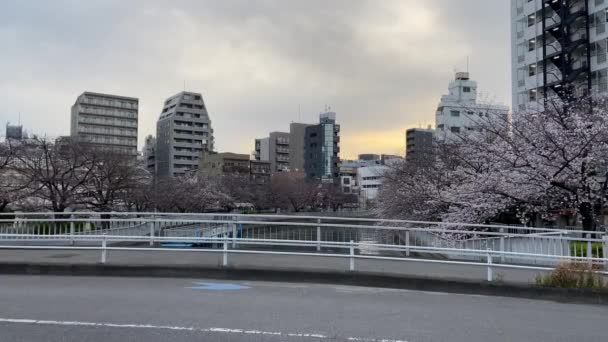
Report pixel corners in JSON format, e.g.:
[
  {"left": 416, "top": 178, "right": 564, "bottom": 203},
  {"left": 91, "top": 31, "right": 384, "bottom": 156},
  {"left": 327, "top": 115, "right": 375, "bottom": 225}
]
[{"left": 0, "top": 318, "right": 408, "bottom": 342}]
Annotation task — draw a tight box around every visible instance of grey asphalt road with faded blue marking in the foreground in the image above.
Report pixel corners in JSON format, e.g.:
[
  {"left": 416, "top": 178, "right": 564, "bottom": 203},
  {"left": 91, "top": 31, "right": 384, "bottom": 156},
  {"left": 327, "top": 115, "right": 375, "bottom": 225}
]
[{"left": 0, "top": 276, "right": 608, "bottom": 342}]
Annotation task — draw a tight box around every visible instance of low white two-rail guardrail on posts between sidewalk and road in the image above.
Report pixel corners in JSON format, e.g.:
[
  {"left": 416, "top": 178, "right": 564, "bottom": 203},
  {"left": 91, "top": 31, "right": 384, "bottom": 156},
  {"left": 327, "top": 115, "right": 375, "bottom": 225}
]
[{"left": 0, "top": 234, "right": 608, "bottom": 281}]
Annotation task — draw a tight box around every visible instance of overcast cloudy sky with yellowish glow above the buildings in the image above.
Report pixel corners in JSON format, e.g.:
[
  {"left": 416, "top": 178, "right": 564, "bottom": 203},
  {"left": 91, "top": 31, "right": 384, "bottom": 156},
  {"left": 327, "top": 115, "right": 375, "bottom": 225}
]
[{"left": 0, "top": 0, "right": 510, "bottom": 158}]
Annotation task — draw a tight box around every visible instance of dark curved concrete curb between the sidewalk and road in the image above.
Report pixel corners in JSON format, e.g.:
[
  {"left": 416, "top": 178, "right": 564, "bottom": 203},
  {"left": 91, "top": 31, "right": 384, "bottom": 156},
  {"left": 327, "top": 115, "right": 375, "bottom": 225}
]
[{"left": 0, "top": 263, "right": 608, "bottom": 305}]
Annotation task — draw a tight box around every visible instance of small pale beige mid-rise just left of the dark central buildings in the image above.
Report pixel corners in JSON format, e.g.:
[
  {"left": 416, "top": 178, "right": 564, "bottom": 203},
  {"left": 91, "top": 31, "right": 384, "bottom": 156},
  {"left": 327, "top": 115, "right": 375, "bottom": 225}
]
[{"left": 255, "top": 132, "right": 290, "bottom": 173}]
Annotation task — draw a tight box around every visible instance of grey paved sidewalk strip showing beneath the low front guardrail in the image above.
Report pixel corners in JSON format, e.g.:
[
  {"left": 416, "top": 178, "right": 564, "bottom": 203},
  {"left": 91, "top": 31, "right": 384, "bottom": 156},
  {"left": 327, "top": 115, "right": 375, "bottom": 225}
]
[{"left": 0, "top": 250, "right": 542, "bottom": 284}]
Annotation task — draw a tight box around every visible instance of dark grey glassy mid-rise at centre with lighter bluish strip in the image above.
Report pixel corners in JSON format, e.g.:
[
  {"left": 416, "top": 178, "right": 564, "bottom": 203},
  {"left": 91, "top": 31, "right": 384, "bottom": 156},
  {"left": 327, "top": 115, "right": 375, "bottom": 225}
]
[{"left": 304, "top": 112, "right": 340, "bottom": 184}]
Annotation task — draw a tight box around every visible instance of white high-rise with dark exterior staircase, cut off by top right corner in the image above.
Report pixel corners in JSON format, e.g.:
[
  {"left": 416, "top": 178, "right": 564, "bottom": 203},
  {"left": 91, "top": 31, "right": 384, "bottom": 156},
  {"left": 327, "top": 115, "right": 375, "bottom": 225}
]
[{"left": 511, "top": 0, "right": 608, "bottom": 111}]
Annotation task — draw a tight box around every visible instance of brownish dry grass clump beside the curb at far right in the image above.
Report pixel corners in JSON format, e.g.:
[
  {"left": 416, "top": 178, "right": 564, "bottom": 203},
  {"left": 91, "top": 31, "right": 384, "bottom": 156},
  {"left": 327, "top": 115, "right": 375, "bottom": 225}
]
[{"left": 536, "top": 262, "right": 608, "bottom": 289}]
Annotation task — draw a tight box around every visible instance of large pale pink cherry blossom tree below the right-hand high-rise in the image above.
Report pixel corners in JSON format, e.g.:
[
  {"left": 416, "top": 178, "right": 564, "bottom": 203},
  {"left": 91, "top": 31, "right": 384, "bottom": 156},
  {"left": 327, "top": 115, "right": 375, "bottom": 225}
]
[{"left": 378, "top": 97, "right": 608, "bottom": 230}]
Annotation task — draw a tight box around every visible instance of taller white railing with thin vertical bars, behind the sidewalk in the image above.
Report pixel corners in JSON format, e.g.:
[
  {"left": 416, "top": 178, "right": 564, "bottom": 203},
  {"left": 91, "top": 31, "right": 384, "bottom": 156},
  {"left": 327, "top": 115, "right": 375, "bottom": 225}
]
[{"left": 0, "top": 212, "right": 608, "bottom": 266}]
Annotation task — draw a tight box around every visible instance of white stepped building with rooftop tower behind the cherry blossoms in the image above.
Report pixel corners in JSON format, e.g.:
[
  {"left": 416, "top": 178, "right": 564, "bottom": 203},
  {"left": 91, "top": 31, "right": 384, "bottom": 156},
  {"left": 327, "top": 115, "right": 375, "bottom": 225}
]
[{"left": 435, "top": 72, "right": 509, "bottom": 140}]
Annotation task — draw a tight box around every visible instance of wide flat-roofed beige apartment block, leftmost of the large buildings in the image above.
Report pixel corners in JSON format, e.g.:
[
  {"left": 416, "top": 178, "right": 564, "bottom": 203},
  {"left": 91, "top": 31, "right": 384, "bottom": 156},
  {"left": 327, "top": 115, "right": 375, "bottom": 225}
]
[{"left": 70, "top": 91, "right": 139, "bottom": 156}]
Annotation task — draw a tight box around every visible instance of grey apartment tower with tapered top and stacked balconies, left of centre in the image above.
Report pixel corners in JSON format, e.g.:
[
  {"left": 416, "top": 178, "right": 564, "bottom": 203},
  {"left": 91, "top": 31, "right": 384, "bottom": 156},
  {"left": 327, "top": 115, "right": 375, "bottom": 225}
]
[{"left": 155, "top": 91, "right": 213, "bottom": 177}]
